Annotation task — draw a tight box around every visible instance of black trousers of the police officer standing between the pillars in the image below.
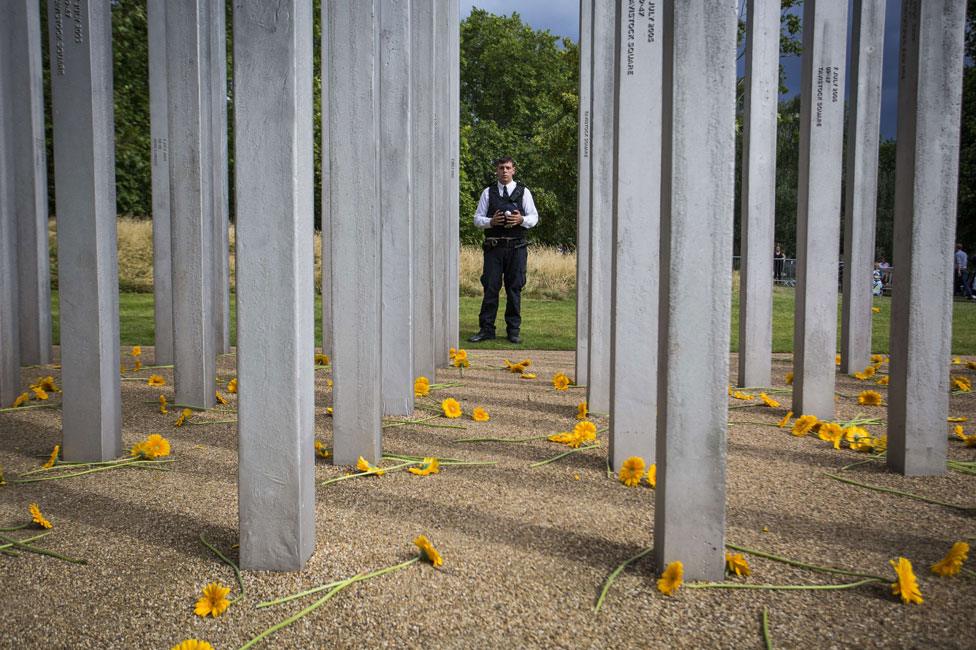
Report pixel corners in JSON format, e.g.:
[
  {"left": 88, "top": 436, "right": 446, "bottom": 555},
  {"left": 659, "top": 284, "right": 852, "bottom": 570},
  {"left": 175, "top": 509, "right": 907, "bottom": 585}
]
[{"left": 478, "top": 242, "right": 528, "bottom": 334}]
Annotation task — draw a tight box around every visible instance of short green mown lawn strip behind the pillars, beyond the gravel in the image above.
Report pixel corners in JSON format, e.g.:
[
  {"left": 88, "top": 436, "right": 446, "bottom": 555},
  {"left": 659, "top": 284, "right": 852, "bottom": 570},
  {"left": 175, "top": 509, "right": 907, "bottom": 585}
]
[{"left": 51, "top": 287, "right": 976, "bottom": 354}]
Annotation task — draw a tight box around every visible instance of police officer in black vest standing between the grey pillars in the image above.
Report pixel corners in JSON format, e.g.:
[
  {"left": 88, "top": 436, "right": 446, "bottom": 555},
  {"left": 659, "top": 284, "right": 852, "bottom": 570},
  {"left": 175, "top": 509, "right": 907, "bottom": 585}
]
[{"left": 468, "top": 156, "right": 539, "bottom": 343}]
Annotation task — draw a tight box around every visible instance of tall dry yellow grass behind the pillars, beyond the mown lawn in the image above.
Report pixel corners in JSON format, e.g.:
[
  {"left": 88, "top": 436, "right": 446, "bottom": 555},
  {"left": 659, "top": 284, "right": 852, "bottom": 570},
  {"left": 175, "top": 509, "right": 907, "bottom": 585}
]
[{"left": 48, "top": 217, "right": 576, "bottom": 300}]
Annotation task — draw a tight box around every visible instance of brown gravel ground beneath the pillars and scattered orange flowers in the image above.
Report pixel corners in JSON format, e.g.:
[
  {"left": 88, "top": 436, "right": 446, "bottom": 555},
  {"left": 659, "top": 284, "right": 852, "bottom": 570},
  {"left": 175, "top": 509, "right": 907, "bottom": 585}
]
[{"left": 0, "top": 348, "right": 976, "bottom": 650}]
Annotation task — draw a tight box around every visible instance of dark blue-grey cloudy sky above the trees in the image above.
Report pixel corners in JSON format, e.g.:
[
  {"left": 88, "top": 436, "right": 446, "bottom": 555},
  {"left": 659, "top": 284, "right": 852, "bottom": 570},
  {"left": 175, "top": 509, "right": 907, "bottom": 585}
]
[{"left": 461, "top": 0, "right": 901, "bottom": 138}]
